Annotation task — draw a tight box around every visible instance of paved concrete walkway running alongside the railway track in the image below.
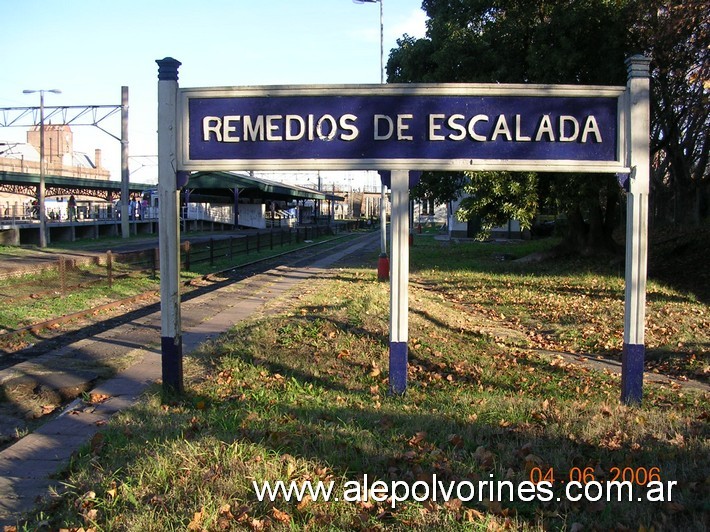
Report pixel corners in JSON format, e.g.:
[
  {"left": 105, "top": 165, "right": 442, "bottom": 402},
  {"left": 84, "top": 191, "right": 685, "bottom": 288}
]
[{"left": 0, "top": 233, "right": 379, "bottom": 525}]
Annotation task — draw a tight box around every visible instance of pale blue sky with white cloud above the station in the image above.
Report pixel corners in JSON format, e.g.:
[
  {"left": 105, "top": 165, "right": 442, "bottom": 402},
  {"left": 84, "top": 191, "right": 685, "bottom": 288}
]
[{"left": 0, "top": 0, "right": 426, "bottom": 191}]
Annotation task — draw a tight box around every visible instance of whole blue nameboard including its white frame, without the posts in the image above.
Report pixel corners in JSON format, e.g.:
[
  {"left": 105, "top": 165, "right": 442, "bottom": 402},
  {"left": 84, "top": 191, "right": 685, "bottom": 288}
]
[{"left": 178, "top": 84, "right": 625, "bottom": 172}]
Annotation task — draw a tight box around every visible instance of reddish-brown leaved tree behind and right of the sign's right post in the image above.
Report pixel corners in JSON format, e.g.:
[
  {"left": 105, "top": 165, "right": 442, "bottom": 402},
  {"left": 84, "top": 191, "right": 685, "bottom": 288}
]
[{"left": 635, "top": 0, "right": 710, "bottom": 223}]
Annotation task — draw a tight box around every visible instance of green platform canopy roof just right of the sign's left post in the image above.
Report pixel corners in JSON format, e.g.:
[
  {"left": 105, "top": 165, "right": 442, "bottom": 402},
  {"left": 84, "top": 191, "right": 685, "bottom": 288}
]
[{"left": 184, "top": 172, "right": 344, "bottom": 203}]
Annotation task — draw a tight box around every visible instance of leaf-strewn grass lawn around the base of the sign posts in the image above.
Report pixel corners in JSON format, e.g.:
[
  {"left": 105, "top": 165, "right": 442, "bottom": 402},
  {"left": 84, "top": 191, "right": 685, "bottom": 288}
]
[{"left": 15, "top": 236, "right": 710, "bottom": 531}]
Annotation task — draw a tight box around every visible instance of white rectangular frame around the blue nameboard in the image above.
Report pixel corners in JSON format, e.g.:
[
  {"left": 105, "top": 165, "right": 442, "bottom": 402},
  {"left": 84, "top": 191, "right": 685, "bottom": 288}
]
[{"left": 177, "top": 83, "right": 630, "bottom": 173}]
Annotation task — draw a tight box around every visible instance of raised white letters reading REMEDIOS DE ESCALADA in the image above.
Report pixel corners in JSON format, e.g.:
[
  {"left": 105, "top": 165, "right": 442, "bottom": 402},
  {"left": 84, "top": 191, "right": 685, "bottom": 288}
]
[{"left": 202, "top": 113, "right": 602, "bottom": 144}]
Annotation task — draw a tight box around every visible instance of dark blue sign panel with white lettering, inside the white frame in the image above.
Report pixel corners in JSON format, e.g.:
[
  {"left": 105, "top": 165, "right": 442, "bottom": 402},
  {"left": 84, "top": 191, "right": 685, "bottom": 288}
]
[{"left": 182, "top": 93, "right": 621, "bottom": 165}]
